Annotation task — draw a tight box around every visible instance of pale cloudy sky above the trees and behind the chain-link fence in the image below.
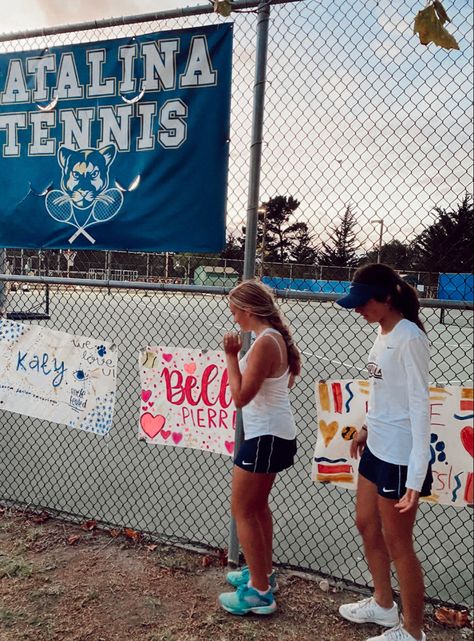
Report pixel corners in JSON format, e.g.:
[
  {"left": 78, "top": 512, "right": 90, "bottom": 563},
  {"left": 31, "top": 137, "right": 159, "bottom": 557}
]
[{"left": 1, "top": 0, "right": 473, "bottom": 255}]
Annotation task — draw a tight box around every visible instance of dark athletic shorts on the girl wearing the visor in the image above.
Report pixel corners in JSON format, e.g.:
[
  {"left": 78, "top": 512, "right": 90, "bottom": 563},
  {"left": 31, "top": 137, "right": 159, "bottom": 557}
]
[{"left": 359, "top": 446, "right": 433, "bottom": 499}]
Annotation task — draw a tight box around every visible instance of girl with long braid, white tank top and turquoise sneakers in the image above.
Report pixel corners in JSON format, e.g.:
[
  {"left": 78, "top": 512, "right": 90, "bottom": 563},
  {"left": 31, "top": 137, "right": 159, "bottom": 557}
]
[{"left": 219, "top": 281, "right": 300, "bottom": 614}]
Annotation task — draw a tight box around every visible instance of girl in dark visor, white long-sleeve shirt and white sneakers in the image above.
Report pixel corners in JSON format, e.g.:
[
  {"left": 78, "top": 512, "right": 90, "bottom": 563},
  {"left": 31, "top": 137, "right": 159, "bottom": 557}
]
[{"left": 337, "top": 264, "right": 432, "bottom": 641}]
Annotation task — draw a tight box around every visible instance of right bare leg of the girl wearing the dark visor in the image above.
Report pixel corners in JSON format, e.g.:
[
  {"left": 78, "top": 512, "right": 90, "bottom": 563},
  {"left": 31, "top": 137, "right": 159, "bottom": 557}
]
[{"left": 378, "top": 496, "right": 425, "bottom": 639}]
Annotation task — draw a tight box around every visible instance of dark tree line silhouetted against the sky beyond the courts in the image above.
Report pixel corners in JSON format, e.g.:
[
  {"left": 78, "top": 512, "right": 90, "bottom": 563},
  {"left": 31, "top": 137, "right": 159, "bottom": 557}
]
[{"left": 221, "top": 194, "right": 474, "bottom": 273}]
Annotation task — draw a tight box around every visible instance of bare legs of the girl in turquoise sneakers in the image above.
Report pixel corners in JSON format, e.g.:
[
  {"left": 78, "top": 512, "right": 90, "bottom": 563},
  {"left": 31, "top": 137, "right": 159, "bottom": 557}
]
[{"left": 232, "top": 466, "right": 276, "bottom": 591}]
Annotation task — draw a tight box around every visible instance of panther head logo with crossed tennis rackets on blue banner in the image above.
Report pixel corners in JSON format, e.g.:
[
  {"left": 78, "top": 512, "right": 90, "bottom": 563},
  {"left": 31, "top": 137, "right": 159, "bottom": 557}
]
[{"left": 45, "top": 144, "right": 123, "bottom": 244}]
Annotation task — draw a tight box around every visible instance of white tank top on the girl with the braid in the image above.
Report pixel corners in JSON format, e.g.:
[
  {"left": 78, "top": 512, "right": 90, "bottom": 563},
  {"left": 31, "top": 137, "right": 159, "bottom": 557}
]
[{"left": 239, "top": 327, "right": 296, "bottom": 441}]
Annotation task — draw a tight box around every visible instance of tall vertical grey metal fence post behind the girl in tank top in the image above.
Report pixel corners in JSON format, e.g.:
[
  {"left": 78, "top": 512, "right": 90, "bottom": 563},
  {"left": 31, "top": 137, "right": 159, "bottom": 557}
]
[{"left": 228, "top": 0, "right": 270, "bottom": 565}]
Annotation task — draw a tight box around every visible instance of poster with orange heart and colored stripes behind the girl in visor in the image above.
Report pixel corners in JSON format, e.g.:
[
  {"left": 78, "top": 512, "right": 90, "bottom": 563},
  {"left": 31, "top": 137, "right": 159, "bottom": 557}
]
[{"left": 311, "top": 380, "right": 474, "bottom": 507}]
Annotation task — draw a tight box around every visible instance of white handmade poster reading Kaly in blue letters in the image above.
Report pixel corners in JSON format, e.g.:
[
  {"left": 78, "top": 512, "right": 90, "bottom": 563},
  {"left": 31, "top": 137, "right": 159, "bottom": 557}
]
[{"left": 0, "top": 319, "right": 117, "bottom": 436}]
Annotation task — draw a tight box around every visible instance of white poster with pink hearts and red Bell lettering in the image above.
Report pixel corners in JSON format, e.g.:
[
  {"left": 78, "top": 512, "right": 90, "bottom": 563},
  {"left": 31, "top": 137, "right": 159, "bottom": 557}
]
[{"left": 138, "top": 346, "right": 236, "bottom": 456}]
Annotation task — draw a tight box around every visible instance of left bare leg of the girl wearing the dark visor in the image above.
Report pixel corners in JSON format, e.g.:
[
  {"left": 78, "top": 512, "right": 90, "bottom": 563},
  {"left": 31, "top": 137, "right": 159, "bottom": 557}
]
[{"left": 356, "top": 474, "right": 395, "bottom": 608}]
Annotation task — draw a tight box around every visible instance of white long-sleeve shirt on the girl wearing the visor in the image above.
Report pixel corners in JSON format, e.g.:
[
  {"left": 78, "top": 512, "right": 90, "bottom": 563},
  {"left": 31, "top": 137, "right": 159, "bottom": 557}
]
[{"left": 366, "top": 319, "right": 431, "bottom": 491}]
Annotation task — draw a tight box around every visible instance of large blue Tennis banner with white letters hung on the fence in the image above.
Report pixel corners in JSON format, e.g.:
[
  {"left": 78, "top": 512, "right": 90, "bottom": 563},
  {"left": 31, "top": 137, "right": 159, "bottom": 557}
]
[{"left": 0, "top": 24, "right": 232, "bottom": 252}]
